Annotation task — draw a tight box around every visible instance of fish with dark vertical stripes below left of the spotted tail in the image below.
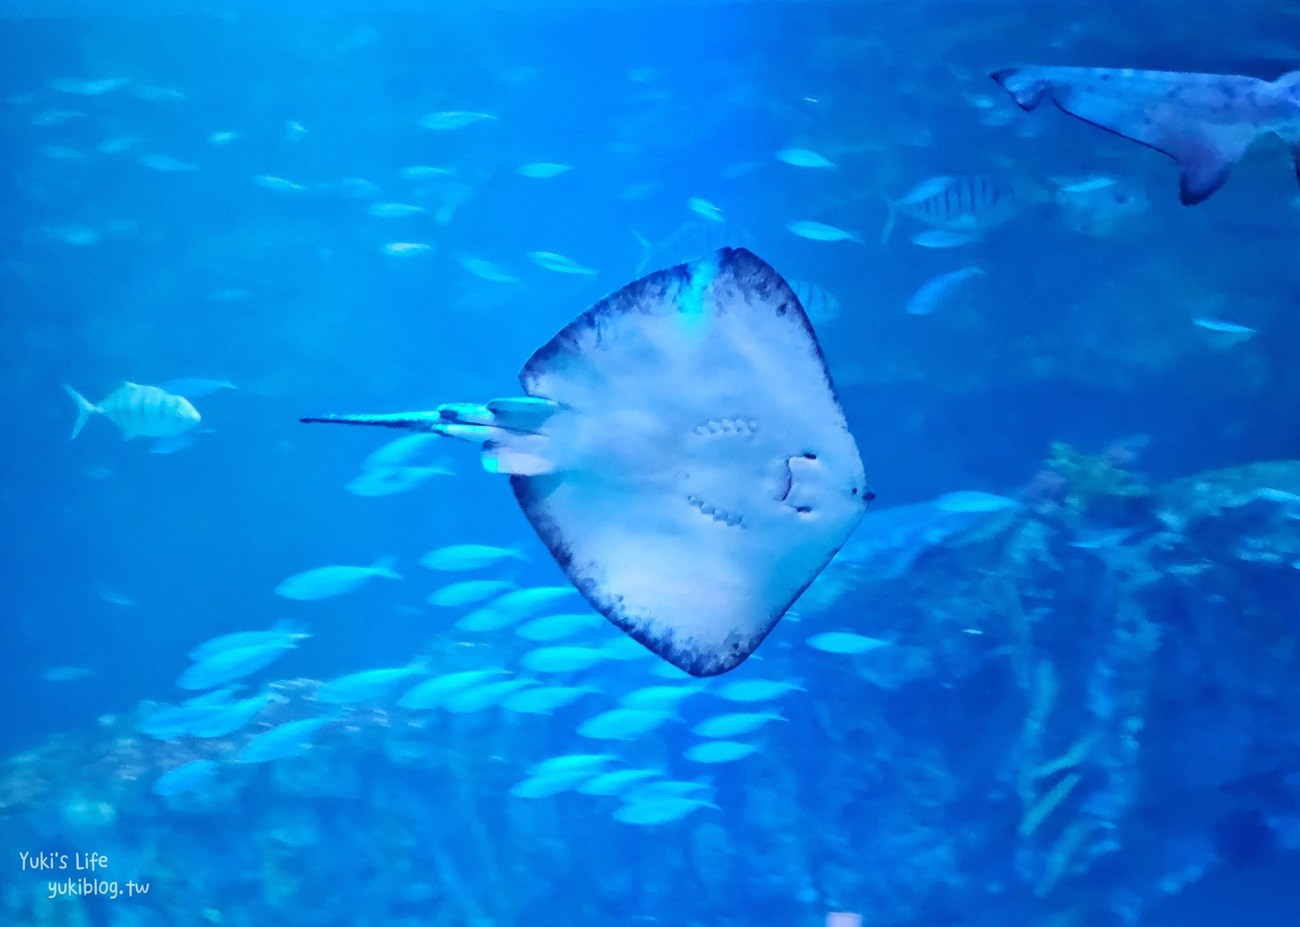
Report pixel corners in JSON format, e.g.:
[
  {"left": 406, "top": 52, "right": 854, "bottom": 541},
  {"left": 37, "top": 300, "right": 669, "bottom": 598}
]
[{"left": 880, "top": 174, "right": 1044, "bottom": 242}]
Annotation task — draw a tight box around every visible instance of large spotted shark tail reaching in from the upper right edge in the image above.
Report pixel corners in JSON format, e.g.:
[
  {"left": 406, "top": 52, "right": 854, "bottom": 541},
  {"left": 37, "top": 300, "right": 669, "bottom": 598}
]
[{"left": 992, "top": 66, "right": 1300, "bottom": 205}]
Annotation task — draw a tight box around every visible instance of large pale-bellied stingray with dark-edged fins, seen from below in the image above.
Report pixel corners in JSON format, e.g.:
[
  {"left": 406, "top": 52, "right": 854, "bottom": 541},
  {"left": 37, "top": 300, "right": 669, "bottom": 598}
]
[{"left": 303, "top": 248, "right": 871, "bottom": 676}]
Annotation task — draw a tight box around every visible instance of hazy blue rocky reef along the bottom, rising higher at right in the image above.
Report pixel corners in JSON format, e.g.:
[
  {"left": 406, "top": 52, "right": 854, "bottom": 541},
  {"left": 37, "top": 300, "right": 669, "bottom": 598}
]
[{"left": 0, "top": 460, "right": 1300, "bottom": 927}]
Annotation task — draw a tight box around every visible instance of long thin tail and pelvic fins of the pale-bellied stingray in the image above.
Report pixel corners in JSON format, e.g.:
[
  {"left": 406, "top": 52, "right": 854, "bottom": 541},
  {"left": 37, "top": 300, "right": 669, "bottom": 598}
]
[{"left": 299, "top": 397, "right": 562, "bottom": 476}]
